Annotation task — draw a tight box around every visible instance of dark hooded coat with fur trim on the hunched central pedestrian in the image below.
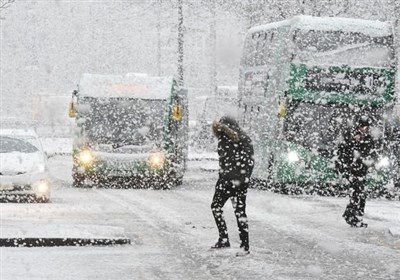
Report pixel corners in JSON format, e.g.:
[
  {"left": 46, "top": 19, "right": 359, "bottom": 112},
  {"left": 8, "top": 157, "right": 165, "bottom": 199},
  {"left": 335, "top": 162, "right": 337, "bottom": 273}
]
[{"left": 213, "top": 117, "right": 254, "bottom": 182}]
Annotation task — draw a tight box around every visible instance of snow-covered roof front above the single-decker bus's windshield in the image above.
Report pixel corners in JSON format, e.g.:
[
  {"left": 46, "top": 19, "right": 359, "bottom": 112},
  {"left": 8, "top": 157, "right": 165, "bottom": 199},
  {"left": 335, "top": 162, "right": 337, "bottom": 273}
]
[{"left": 79, "top": 73, "right": 173, "bottom": 99}]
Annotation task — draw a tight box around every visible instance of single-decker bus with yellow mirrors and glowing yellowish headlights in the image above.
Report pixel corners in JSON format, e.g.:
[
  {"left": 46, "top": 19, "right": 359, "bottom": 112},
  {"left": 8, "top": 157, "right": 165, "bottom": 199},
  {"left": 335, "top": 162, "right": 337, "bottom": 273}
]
[{"left": 70, "top": 73, "right": 188, "bottom": 188}]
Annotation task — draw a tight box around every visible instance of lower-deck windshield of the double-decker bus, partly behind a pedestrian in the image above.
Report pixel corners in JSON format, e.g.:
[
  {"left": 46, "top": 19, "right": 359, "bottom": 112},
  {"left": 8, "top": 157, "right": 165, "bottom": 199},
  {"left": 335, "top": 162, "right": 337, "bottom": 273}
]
[{"left": 285, "top": 103, "right": 383, "bottom": 156}]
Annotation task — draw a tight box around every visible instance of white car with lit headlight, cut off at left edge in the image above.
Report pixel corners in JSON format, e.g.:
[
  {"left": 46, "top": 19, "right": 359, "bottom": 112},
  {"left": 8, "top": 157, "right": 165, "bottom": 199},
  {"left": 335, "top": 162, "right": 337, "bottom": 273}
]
[{"left": 0, "top": 129, "right": 51, "bottom": 202}]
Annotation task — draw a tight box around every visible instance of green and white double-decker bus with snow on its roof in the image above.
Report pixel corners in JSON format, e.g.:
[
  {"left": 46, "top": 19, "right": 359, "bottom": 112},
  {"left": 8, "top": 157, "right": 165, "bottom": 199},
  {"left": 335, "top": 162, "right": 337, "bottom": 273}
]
[{"left": 238, "top": 16, "right": 396, "bottom": 193}]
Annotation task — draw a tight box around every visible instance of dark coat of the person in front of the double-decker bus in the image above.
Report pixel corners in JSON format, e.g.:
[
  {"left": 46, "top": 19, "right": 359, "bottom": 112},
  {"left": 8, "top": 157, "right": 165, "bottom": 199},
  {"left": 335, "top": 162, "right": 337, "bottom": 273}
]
[{"left": 336, "top": 126, "right": 376, "bottom": 178}]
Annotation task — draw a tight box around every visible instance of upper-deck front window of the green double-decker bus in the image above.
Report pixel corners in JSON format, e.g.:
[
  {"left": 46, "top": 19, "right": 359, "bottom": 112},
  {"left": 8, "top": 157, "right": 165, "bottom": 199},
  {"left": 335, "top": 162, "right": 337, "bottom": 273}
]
[{"left": 294, "top": 30, "right": 394, "bottom": 67}]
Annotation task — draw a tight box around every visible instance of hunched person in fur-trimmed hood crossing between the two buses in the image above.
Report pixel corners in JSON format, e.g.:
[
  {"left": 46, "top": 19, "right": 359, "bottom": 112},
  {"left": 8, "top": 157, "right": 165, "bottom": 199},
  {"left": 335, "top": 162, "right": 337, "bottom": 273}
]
[{"left": 211, "top": 117, "right": 254, "bottom": 255}]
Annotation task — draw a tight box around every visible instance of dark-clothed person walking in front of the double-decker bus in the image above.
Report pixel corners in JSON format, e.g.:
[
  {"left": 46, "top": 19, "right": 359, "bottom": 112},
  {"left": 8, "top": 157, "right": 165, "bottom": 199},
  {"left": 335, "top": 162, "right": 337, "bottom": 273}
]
[{"left": 336, "top": 116, "right": 375, "bottom": 227}]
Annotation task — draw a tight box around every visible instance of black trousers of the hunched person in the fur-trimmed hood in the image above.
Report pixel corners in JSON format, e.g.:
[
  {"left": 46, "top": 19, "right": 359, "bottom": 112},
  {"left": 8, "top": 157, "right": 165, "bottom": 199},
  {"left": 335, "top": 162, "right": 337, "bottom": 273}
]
[{"left": 211, "top": 177, "right": 249, "bottom": 249}]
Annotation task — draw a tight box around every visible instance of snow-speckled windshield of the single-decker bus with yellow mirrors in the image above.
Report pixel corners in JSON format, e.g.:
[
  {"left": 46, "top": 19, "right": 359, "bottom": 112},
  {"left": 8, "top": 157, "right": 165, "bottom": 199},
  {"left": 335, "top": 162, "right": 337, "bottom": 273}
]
[{"left": 78, "top": 97, "right": 166, "bottom": 146}]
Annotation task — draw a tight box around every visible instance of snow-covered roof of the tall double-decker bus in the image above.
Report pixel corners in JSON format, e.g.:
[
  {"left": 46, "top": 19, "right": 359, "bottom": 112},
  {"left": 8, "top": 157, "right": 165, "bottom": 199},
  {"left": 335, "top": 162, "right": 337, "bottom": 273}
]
[{"left": 249, "top": 15, "right": 392, "bottom": 37}]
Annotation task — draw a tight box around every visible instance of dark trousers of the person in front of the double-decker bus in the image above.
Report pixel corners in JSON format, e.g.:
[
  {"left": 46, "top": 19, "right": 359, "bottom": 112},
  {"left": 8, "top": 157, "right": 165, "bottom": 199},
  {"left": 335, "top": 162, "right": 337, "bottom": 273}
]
[{"left": 343, "top": 177, "right": 366, "bottom": 226}]
